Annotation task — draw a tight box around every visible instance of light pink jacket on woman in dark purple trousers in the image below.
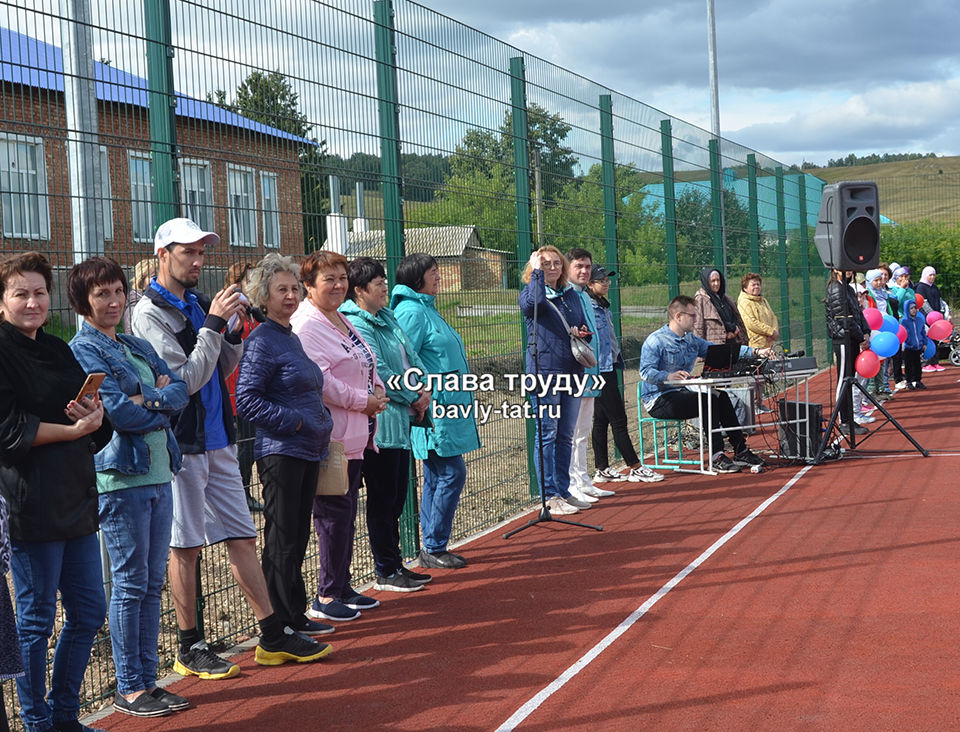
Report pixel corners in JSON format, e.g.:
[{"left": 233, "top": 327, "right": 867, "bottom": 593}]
[{"left": 290, "top": 300, "right": 383, "bottom": 460}]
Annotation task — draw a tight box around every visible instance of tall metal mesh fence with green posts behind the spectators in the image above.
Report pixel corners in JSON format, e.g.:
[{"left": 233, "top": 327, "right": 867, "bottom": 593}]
[{"left": 0, "top": 0, "right": 936, "bottom": 724}]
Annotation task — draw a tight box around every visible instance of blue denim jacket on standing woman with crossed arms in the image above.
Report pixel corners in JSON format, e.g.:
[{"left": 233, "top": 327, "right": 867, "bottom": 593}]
[{"left": 70, "top": 323, "right": 190, "bottom": 475}]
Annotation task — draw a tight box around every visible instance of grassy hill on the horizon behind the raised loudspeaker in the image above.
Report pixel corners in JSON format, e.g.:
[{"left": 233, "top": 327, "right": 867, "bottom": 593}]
[{"left": 804, "top": 157, "right": 960, "bottom": 223}]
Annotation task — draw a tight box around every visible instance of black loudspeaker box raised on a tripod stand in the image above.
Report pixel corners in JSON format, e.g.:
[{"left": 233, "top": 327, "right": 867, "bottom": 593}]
[{"left": 814, "top": 180, "right": 880, "bottom": 272}]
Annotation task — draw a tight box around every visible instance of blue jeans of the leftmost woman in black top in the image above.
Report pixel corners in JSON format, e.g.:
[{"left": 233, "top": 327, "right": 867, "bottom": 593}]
[{"left": 10, "top": 534, "right": 106, "bottom": 732}]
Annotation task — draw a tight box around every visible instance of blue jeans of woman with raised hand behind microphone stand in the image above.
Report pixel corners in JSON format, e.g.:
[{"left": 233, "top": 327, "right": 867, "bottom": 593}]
[{"left": 530, "top": 393, "right": 580, "bottom": 499}]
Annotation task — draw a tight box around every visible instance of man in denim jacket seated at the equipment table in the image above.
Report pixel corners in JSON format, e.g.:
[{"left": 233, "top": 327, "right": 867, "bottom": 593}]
[{"left": 640, "top": 295, "right": 773, "bottom": 473}]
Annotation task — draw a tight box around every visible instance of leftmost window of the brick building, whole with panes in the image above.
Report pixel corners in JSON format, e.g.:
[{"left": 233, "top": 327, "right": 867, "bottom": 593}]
[{"left": 0, "top": 135, "right": 50, "bottom": 240}]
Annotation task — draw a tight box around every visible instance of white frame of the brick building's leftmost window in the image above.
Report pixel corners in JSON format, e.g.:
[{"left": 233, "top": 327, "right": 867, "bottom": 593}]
[{"left": 0, "top": 133, "right": 50, "bottom": 241}]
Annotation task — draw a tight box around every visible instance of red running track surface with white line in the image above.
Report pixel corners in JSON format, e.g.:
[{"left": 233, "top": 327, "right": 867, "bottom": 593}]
[{"left": 98, "top": 368, "right": 960, "bottom": 732}]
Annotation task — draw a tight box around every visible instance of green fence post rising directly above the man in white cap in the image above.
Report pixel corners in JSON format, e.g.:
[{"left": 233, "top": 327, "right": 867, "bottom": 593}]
[{"left": 143, "top": 0, "right": 180, "bottom": 226}]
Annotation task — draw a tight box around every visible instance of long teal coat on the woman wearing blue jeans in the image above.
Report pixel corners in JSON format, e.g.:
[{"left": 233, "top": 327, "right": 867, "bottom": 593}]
[{"left": 390, "top": 285, "right": 480, "bottom": 460}]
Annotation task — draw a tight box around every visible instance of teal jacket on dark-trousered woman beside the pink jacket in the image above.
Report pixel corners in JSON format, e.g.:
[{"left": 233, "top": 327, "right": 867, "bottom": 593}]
[{"left": 340, "top": 300, "right": 425, "bottom": 450}]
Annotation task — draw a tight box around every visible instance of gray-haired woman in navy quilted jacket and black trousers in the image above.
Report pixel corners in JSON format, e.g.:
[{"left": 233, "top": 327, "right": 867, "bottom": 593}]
[{"left": 237, "top": 252, "right": 333, "bottom": 636}]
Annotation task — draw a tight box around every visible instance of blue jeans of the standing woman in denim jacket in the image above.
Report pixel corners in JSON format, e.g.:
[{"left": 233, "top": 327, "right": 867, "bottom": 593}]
[{"left": 100, "top": 483, "right": 173, "bottom": 694}]
